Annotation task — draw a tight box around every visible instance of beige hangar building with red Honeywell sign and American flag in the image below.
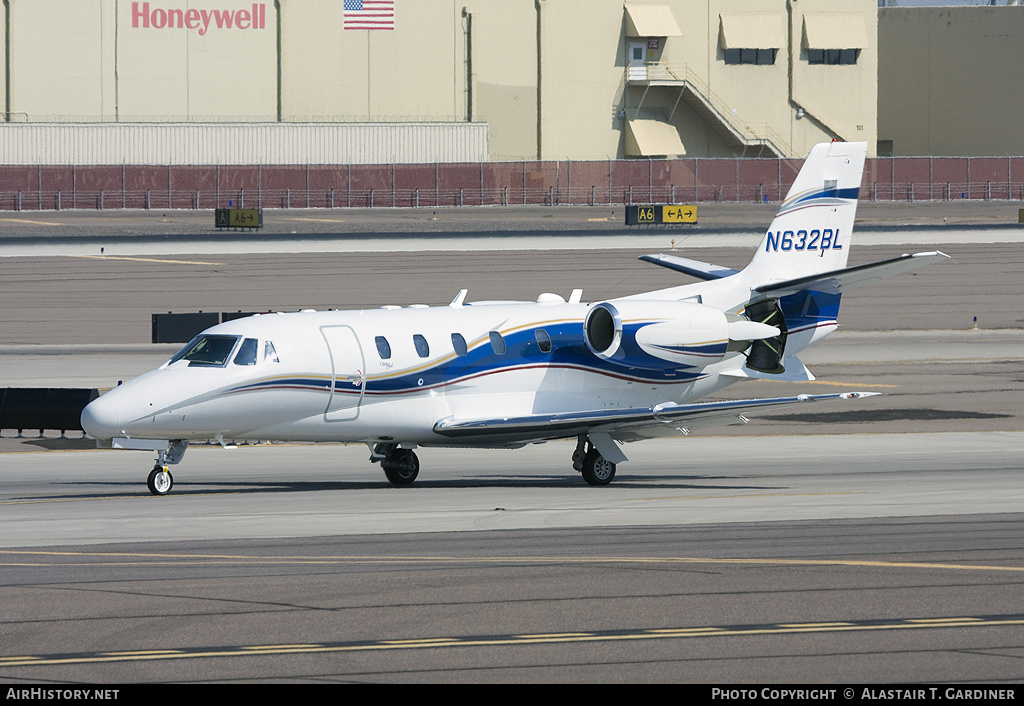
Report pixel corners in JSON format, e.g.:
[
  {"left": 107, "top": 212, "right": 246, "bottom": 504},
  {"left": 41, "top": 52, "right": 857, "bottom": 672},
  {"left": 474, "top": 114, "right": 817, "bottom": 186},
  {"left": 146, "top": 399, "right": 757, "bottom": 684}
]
[{"left": 0, "top": 0, "right": 879, "bottom": 164}]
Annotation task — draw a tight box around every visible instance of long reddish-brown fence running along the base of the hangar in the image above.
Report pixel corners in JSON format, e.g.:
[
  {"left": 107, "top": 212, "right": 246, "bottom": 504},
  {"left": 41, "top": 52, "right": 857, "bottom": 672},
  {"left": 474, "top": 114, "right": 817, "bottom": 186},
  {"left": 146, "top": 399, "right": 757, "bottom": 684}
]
[{"left": 0, "top": 156, "right": 1024, "bottom": 211}]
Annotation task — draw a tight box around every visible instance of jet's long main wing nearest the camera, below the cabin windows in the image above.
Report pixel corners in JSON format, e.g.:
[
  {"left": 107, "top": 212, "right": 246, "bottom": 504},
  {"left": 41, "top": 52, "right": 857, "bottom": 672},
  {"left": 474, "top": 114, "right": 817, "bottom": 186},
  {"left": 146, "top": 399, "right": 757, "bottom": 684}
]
[{"left": 434, "top": 392, "right": 879, "bottom": 441}]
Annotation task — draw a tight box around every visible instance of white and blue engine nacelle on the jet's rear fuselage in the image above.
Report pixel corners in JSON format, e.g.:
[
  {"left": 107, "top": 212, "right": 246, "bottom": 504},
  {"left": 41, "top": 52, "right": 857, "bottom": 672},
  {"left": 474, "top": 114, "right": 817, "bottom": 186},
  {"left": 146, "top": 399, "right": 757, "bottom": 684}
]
[{"left": 584, "top": 299, "right": 779, "bottom": 370}]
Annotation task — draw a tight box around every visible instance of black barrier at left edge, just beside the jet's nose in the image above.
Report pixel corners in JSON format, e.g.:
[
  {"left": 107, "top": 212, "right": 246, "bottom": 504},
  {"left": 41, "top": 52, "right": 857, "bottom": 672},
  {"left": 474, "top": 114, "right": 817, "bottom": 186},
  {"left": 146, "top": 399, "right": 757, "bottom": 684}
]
[{"left": 0, "top": 387, "right": 99, "bottom": 433}]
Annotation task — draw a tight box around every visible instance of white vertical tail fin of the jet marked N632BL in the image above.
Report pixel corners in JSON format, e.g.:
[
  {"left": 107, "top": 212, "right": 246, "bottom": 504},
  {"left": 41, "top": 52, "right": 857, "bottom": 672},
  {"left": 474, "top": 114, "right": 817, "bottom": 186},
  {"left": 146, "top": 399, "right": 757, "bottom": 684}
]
[{"left": 742, "top": 142, "right": 867, "bottom": 289}]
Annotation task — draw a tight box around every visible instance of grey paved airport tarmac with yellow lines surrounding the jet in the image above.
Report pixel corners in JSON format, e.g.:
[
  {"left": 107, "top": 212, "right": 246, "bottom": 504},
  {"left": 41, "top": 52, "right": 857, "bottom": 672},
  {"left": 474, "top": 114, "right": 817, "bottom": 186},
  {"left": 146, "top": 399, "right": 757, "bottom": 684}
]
[{"left": 0, "top": 204, "right": 1024, "bottom": 683}]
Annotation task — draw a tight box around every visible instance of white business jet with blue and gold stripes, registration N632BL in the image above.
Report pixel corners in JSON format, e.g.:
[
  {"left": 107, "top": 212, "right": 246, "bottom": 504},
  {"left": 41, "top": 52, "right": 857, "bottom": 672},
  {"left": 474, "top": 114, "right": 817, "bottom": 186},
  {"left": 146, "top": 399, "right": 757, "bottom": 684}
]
[{"left": 82, "top": 142, "right": 947, "bottom": 495}]
